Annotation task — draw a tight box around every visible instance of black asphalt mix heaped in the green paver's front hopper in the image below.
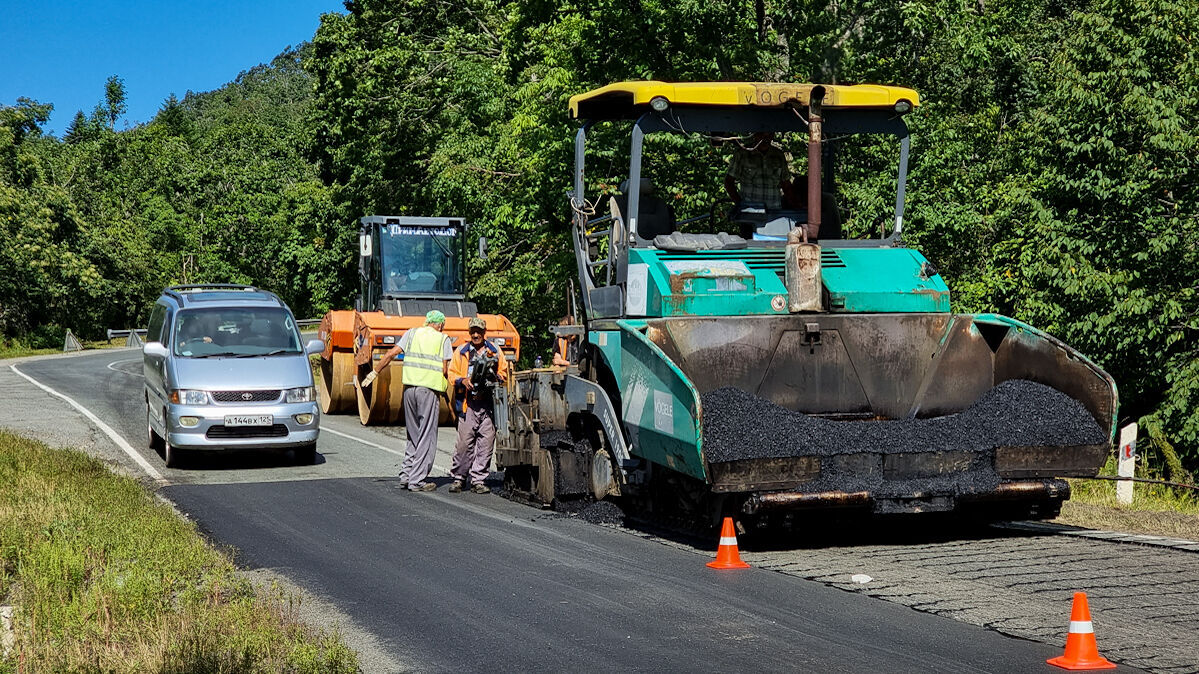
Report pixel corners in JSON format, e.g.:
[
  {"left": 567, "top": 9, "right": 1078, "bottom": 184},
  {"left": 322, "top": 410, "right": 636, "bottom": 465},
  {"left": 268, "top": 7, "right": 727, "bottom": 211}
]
[{"left": 701, "top": 379, "right": 1108, "bottom": 493}]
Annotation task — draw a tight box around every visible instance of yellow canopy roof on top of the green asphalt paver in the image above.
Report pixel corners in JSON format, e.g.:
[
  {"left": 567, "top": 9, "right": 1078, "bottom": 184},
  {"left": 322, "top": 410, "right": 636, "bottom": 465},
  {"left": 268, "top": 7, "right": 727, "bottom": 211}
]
[{"left": 571, "top": 80, "right": 920, "bottom": 119}]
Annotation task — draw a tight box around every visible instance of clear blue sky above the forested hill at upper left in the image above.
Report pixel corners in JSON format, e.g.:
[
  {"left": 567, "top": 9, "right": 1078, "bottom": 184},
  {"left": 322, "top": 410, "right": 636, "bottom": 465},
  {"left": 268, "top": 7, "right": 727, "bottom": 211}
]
[{"left": 0, "top": 0, "right": 345, "bottom": 136}]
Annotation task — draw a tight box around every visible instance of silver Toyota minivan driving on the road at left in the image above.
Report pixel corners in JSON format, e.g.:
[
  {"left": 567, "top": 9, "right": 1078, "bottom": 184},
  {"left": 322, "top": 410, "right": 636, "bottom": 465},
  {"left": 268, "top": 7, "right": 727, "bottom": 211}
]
[{"left": 141, "top": 283, "right": 325, "bottom": 468}]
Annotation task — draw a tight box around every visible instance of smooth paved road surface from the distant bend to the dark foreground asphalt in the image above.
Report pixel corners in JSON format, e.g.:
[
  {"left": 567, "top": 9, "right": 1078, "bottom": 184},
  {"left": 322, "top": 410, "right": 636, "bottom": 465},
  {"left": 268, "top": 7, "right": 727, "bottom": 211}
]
[{"left": 9, "top": 350, "right": 1126, "bottom": 673}]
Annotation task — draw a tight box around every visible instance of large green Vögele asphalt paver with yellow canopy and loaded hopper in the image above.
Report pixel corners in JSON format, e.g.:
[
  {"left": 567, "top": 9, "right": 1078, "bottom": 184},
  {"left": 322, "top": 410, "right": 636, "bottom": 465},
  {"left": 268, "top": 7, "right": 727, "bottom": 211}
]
[{"left": 496, "top": 82, "right": 1117, "bottom": 526}]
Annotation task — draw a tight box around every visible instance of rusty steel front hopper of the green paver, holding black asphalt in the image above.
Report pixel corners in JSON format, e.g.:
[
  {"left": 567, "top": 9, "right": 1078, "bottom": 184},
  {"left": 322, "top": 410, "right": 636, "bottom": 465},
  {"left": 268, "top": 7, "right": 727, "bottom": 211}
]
[{"left": 623, "top": 313, "right": 1116, "bottom": 512}]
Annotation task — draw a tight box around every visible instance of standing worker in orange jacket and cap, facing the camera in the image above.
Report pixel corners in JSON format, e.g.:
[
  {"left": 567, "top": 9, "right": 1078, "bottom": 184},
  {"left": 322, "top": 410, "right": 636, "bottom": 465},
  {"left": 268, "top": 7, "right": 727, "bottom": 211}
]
[{"left": 450, "top": 317, "right": 508, "bottom": 494}]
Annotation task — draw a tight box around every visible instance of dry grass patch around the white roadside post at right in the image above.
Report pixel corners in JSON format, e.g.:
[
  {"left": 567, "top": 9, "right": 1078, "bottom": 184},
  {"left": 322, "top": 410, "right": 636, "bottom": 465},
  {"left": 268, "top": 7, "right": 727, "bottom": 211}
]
[{"left": 1054, "top": 459, "right": 1199, "bottom": 541}]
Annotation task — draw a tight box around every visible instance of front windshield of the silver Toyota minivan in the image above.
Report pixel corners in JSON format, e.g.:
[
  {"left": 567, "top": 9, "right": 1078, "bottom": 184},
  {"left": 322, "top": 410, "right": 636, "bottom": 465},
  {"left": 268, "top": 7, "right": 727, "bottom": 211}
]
[{"left": 174, "top": 307, "right": 302, "bottom": 357}]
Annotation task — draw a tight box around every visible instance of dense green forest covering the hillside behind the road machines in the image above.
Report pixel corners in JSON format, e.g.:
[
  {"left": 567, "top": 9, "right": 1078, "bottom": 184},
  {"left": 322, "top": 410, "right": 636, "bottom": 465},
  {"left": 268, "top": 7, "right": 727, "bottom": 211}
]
[{"left": 0, "top": 0, "right": 1199, "bottom": 479}]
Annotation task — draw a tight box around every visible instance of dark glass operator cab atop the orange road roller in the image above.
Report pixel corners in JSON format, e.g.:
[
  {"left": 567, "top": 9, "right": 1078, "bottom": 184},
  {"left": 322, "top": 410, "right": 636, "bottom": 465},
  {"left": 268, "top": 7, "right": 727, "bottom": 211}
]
[{"left": 356, "top": 216, "right": 466, "bottom": 313}]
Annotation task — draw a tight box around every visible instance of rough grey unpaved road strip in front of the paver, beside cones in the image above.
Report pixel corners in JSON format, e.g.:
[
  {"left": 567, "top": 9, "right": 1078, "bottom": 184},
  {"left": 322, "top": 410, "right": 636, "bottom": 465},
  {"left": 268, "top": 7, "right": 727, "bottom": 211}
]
[{"left": 742, "top": 532, "right": 1199, "bottom": 673}]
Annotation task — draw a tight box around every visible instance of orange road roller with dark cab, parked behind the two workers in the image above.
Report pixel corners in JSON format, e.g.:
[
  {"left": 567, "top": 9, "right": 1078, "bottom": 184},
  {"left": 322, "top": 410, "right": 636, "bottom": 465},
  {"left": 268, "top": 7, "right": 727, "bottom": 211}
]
[{"left": 318, "top": 216, "right": 520, "bottom": 425}]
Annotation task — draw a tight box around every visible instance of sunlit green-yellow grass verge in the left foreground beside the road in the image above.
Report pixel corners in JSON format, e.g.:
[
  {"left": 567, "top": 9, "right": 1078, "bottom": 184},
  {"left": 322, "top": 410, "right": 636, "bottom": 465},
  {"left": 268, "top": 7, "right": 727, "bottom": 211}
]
[{"left": 0, "top": 431, "right": 359, "bottom": 674}]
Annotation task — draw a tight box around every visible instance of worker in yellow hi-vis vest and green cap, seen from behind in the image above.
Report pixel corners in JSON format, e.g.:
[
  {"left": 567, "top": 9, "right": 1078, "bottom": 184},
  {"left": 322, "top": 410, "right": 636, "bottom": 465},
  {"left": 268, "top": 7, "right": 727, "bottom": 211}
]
[{"left": 361, "top": 309, "right": 453, "bottom": 492}]
